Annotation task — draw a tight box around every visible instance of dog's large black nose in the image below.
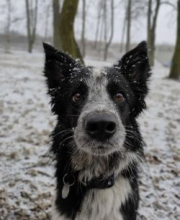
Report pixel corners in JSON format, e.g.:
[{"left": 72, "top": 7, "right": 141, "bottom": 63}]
[{"left": 85, "top": 114, "right": 116, "bottom": 141}]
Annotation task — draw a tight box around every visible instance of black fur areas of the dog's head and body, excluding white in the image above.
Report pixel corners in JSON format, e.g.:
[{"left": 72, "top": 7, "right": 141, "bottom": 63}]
[{"left": 44, "top": 42, "right": 150, "bottom": 220}]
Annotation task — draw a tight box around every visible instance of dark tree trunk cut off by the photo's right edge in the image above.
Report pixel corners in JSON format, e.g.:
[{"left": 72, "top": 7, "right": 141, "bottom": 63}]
[{"left": 169, "top": 0, "right": 180, "bottom": 80}]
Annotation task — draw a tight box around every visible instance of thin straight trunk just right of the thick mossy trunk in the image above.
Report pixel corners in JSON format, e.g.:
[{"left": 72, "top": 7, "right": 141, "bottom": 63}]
[{"left": 81, "top": 0, "right": 86, "bottom": 57}]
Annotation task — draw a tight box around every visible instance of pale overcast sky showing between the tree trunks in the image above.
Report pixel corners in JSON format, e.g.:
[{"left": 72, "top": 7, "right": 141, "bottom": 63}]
[{"left": 0, "top": 0, "right": 177, "bottom": 44}]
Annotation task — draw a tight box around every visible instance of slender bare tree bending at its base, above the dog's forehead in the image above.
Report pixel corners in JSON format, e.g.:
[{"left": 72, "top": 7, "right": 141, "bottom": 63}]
[{"left": 104, "top": 0, "right": 114, "bottom": 60}]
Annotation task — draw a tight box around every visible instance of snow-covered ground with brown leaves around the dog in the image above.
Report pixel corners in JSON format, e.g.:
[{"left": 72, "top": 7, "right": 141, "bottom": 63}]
[{"left": 0, "top": 52, "right": 180, "bottom": 220}]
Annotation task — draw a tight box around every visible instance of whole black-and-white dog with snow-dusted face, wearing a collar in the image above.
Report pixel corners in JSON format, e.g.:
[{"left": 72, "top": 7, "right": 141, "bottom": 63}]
[{"left": 43, "top": 42, "right": 151, "bottom": 220}]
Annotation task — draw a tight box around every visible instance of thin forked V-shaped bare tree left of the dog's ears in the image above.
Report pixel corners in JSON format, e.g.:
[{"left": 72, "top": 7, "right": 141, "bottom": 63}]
[{"left": 25, "top": 0, "right": 38, "bottom": 53}]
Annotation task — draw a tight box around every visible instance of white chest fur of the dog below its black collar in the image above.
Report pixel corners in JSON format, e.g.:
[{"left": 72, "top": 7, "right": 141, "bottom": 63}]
[{"left": 75, "top": 178, "right": 132, "bottom": 220}]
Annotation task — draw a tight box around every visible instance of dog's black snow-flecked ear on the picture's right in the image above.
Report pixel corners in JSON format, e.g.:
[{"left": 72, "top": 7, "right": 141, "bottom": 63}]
[{"left": 115, "top": 41, "right": 150, "bottom": 83}]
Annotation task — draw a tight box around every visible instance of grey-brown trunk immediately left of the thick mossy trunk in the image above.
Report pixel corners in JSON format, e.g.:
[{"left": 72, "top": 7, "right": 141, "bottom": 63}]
[{"left": 53, "top": 0, "right": 61, "bottom": 49}]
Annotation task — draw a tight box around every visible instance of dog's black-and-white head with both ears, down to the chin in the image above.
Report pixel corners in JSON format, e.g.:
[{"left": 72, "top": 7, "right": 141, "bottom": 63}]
[{"left": 44, "top": 42, "right": 150, "bottom": 160}]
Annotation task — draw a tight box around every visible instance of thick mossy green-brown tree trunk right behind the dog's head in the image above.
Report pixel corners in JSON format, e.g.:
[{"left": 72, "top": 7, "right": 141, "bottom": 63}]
[{"left": 59, "top": 0, "right": 83, "bottom": 63}]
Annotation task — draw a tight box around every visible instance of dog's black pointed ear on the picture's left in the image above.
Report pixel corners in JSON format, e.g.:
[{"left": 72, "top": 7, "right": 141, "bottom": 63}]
[{"left": 43, "top": 43, "right": 77, "bottom": 89}]
